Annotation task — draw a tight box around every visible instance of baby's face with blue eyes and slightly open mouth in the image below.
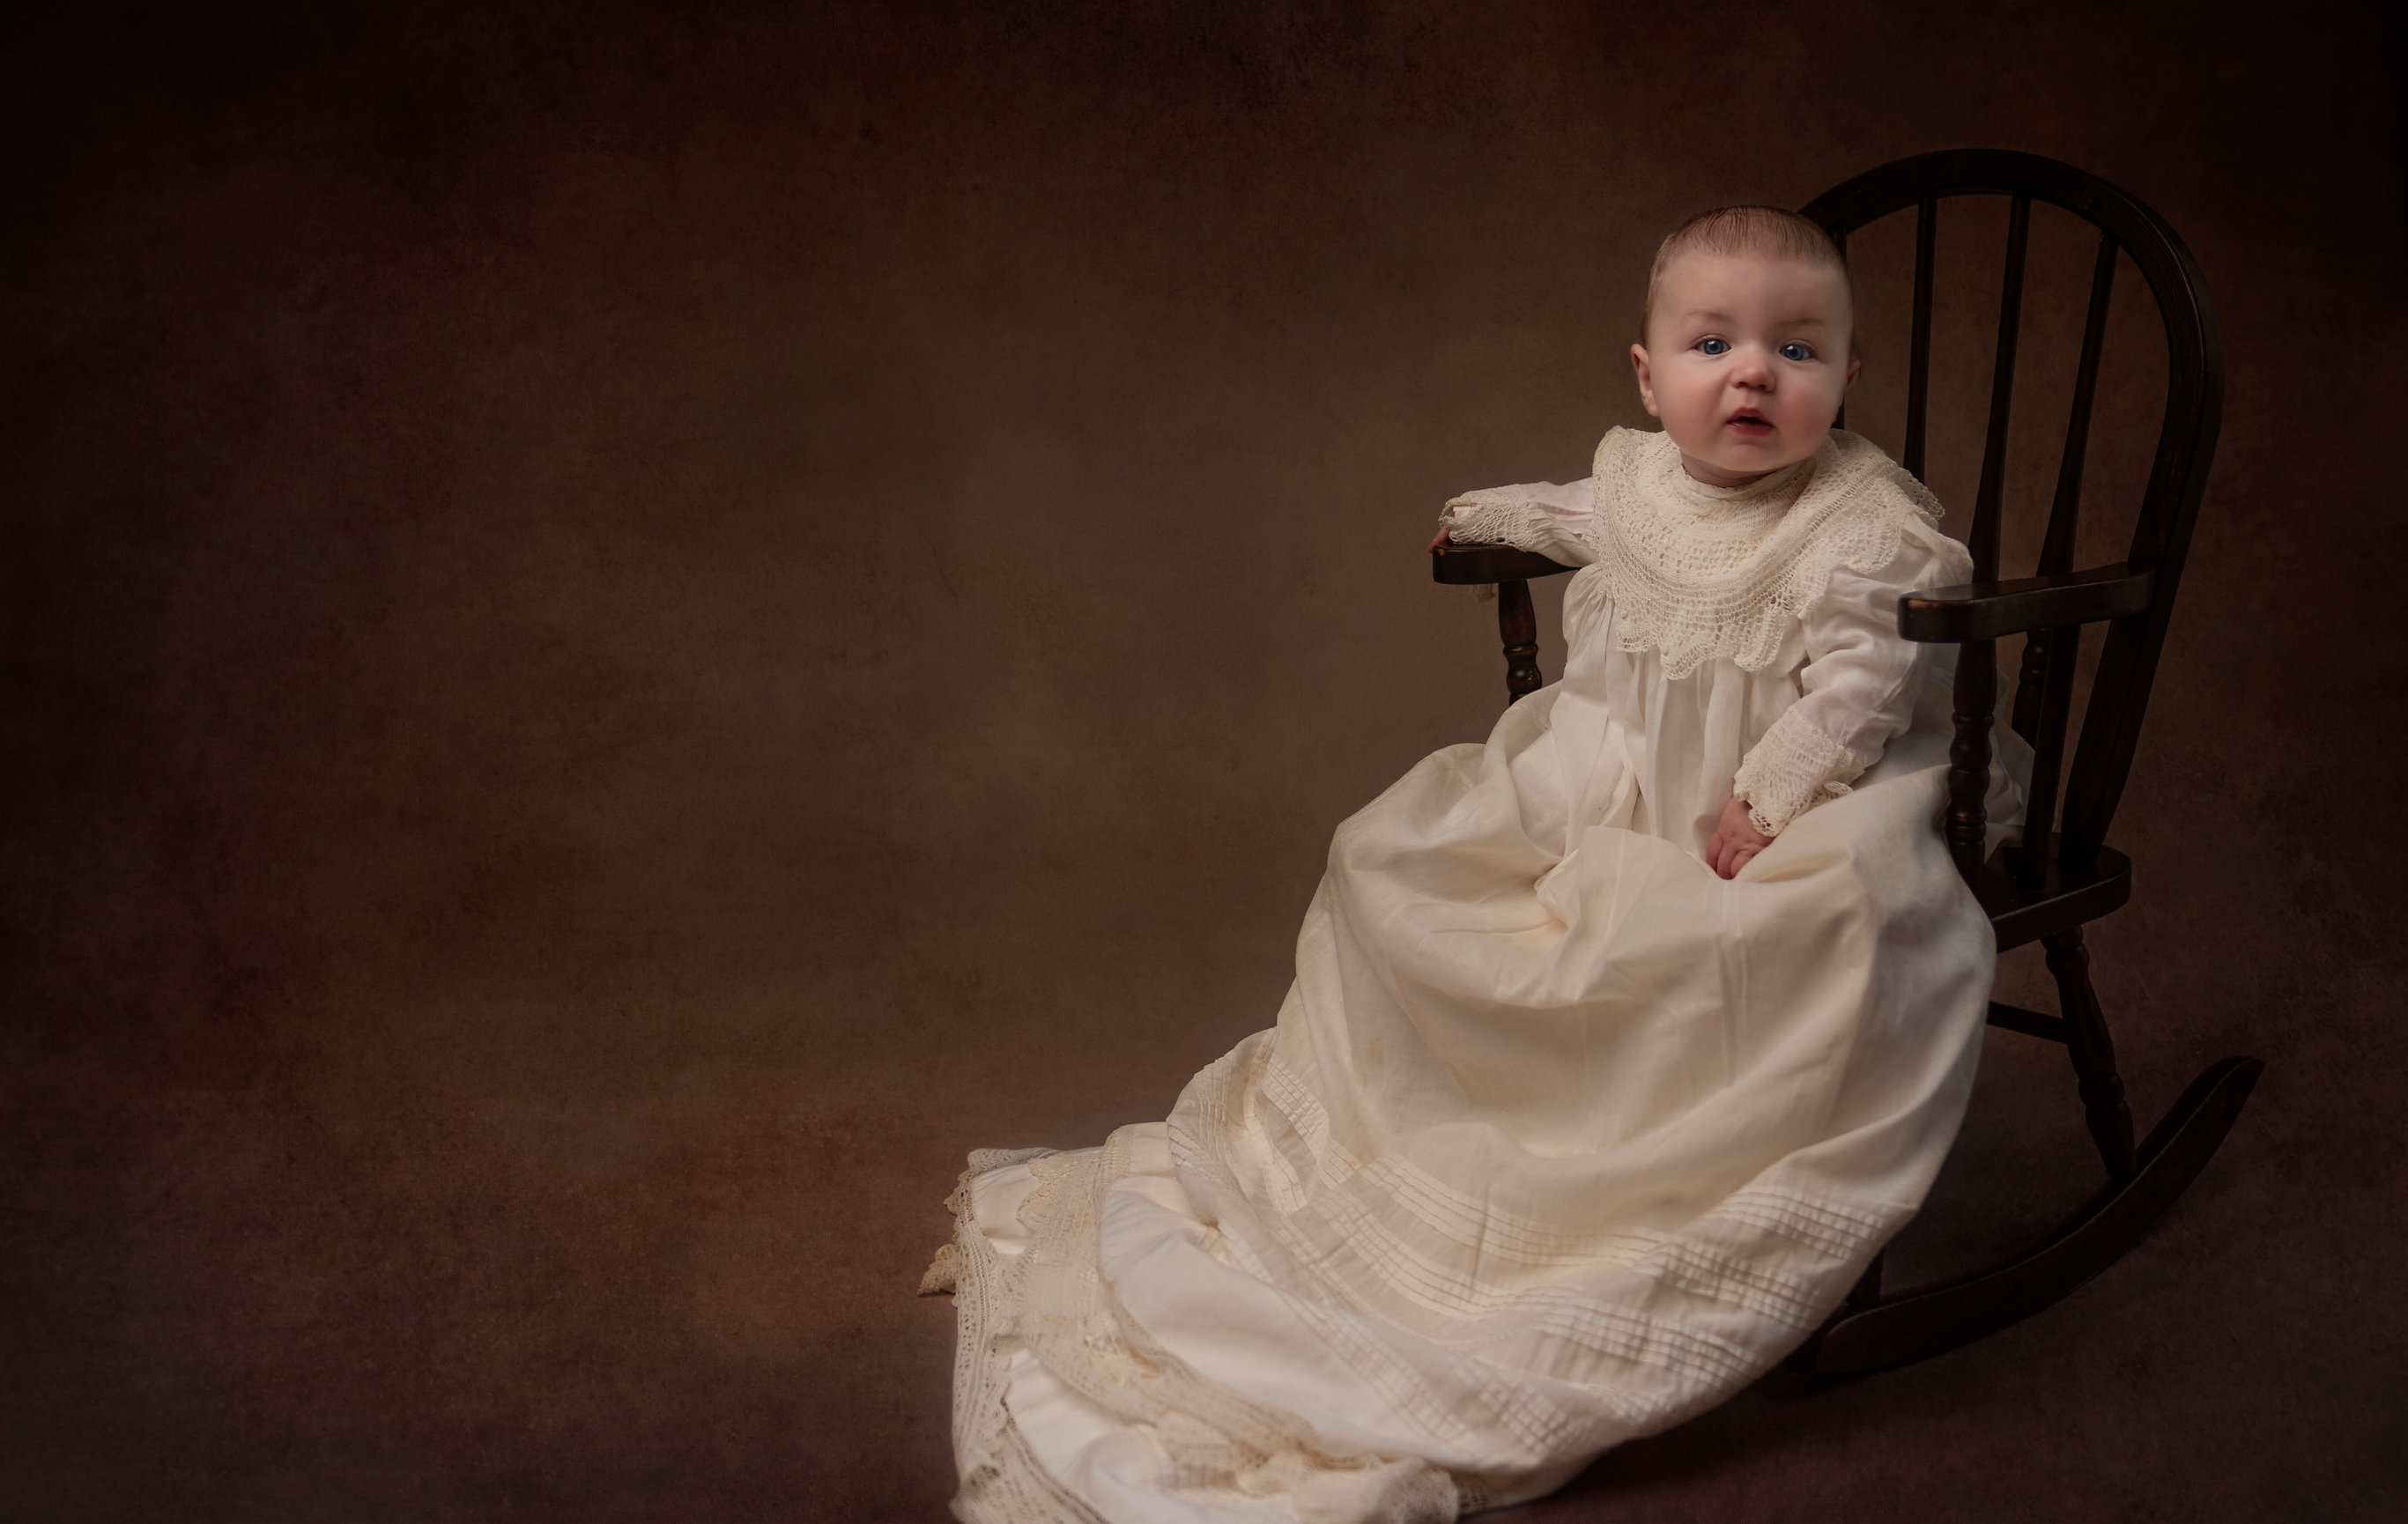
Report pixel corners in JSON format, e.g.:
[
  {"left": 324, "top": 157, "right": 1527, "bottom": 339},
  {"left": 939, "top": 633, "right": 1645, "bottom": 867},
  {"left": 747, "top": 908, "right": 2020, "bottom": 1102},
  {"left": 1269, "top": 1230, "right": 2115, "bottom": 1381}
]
[{"left": 1630, "top": 253, "right": 1856, "bottom": 486}]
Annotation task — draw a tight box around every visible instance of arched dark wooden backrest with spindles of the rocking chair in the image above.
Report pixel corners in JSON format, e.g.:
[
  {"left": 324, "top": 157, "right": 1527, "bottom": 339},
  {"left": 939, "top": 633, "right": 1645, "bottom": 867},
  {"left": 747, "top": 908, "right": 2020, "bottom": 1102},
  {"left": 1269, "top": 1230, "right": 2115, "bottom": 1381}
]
[{"left": 1804, "top": 149, "right": 2225, "bottom": 871}]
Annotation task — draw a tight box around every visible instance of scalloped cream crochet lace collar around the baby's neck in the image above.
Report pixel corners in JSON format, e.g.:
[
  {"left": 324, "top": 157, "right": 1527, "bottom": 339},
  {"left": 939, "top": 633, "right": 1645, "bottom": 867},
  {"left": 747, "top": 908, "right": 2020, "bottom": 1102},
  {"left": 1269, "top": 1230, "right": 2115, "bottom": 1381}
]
[{"left": 1589, "top": 428, "right": 1941, "bottom": 677}]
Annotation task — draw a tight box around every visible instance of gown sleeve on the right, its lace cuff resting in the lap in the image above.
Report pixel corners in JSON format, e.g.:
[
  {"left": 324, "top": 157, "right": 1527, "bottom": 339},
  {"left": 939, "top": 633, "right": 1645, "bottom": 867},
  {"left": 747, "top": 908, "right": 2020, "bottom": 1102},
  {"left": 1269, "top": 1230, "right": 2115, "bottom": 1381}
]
[{"left": 1731, "top": 529, "right": 1972, "bottom": 835}]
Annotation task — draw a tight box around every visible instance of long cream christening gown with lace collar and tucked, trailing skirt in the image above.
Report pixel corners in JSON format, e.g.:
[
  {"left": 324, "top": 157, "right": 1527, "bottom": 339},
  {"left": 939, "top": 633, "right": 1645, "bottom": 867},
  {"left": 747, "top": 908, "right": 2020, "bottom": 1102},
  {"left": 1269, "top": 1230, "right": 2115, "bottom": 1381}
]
[{"left": 930, "top": 428, "right": 2020, "bottom": 1524}]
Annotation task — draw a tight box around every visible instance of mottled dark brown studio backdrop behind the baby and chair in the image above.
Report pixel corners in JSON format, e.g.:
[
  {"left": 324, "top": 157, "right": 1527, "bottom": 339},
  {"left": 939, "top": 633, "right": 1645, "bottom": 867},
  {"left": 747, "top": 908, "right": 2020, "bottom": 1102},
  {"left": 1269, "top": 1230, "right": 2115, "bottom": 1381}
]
[{"left": 0, "top": 0, "right": 2408, "bottom": 1521}]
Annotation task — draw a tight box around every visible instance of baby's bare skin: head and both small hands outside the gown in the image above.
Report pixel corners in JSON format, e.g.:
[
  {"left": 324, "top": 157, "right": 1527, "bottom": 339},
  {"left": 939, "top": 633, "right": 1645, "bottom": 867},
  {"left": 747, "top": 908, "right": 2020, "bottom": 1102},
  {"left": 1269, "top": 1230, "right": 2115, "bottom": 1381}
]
[{"left": 1430, "top": 207, "right": 1859, "bottom": 879}]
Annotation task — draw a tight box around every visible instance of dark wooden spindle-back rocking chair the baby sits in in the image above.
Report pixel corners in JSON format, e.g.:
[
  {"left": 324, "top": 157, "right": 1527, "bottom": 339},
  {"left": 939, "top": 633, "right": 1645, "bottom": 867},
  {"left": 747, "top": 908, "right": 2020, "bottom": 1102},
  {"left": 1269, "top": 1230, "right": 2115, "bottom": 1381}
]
[{"left": 1433, "top": 149, "right": 2264, "bottom": 1375}]
